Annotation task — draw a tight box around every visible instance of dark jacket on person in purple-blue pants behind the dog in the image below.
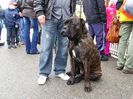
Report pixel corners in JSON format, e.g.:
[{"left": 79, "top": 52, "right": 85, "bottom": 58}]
[{"left": 83, "top": 0, "right": 106, "bottom": 24}]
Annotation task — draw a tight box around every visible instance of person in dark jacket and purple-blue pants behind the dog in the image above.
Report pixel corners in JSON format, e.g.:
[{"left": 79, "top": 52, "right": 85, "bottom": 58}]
[{"left": 83, "top": 0, "right": 108, "bottom": 61}]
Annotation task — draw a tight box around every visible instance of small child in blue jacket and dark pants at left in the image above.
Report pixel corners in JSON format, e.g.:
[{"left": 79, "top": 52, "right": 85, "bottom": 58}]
[{"left": 4, "top": 2, "right": 19, "bottom": 49}]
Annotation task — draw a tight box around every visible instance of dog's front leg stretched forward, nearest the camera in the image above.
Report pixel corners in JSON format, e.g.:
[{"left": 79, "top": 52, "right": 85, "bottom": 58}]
[{"left": 84, "top": 60, "right": 92, "bottom": 92}]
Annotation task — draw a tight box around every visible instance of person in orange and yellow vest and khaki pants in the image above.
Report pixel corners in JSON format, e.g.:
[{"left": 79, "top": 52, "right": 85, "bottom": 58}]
[{"left": 116, "top": 0, "right": 133, "bottom": 74}]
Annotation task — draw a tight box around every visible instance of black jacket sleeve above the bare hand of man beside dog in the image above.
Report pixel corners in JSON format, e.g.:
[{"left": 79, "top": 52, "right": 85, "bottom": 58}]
[{"left": 33, "top": 0, "right": 45, "bottom": 17}]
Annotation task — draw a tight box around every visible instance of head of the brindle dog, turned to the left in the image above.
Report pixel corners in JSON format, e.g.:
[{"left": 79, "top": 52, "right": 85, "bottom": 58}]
[{"left": 61, "top": 16, "right": 88, "bottom": 40}]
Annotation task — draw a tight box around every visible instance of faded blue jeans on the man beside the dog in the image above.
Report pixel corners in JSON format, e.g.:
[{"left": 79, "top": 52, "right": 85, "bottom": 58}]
[{"left": 39, "top": 18, "right": 68, "bottom": 76}]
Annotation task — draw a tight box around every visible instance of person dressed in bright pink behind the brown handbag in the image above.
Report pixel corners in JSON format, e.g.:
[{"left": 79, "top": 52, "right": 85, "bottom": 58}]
[{"left": 104, "top": 1, "right": 116, "bottom": 57}]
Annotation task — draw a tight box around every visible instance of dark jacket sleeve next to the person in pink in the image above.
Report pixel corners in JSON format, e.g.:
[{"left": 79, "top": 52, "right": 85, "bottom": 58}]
[{"left": 97, "top": 0, "right": 106, "bottom": 23}]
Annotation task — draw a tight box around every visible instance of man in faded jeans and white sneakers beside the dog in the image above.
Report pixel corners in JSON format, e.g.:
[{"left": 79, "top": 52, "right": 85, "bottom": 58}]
[{"left": 34, "top": 0, "right": 76, "bottom": 84}]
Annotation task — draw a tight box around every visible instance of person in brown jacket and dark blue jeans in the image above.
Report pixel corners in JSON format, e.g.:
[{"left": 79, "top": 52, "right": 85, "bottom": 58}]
[{"left": 16, "top": 0, "right": 39, "bottom": 54}]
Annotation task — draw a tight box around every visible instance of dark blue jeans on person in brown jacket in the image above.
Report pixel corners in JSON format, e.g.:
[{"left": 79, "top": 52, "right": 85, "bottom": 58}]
[{"left": 24, "top": 17, "right": 39, "bottom": 53}]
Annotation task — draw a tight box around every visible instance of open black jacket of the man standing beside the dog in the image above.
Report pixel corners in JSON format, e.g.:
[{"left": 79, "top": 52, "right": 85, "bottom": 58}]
[{"left": 34, "top": 0, "right": 76, "bottom": 16}]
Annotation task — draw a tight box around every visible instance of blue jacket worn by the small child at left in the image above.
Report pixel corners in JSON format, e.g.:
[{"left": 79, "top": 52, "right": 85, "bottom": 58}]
[{"left": 4, "top": 8, "right": 20, "bottom": 28}]
